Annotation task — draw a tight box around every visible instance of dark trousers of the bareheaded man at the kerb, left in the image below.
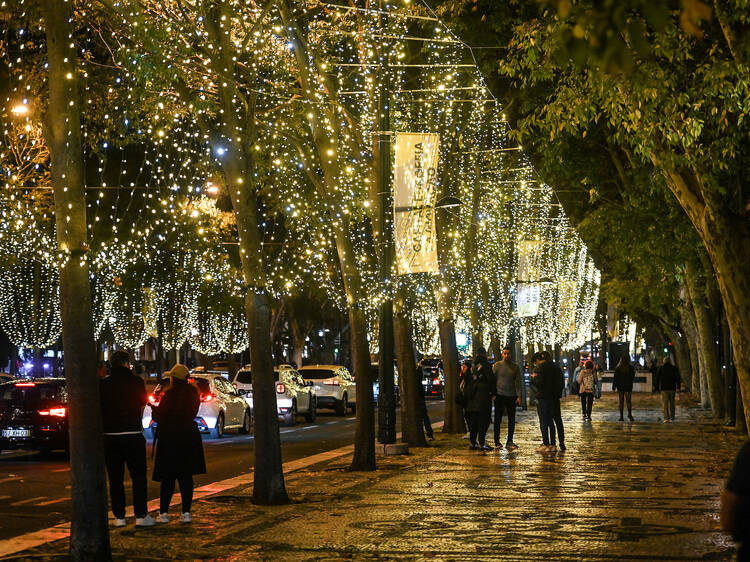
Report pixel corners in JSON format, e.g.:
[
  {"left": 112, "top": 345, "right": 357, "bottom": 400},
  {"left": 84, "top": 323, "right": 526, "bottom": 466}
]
[{"left": 104, "top": 433, "right": 148, "bottom": 519}]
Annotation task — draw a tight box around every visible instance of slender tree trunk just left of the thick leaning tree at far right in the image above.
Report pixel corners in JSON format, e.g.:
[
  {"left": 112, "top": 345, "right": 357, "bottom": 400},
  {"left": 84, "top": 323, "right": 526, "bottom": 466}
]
[{"left": 686, "top": 262, "right": 724, "bottom": 418}]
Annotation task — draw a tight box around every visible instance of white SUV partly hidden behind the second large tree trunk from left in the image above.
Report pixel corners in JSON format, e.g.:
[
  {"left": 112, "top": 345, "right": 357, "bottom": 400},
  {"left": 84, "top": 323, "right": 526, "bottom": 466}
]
[{"left": 232, "top": 365, "right": 318, "bottom": 425}]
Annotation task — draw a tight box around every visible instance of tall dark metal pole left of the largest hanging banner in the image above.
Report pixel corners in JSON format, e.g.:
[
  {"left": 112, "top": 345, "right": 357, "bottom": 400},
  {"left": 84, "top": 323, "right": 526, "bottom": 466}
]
[{"left": 376, "top": 0, "right": 396, "bottom": 444}]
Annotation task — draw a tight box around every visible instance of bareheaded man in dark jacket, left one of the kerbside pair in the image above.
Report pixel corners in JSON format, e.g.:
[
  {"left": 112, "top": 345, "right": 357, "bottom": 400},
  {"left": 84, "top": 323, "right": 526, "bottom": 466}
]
[{"left": 100, "top": 351, "right": 156, "bottom": 527}]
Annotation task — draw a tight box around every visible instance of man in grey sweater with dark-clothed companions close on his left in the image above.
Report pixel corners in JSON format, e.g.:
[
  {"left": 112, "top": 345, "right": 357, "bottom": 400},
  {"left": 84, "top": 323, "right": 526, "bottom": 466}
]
[{"left": 461, "top": 347, "right": 522, "bottom": 451}]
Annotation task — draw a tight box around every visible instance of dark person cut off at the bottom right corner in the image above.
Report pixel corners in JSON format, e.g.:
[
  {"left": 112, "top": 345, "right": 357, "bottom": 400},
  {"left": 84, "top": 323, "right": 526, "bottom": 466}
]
[{"left": 720, "top": 441, "right": 750, "bottom": 562}]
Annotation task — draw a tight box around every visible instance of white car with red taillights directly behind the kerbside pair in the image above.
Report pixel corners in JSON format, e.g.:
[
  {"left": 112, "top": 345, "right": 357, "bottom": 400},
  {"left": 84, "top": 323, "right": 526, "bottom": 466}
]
[{"left": 143, "top": 373, "right": 252, "bottom": 438}]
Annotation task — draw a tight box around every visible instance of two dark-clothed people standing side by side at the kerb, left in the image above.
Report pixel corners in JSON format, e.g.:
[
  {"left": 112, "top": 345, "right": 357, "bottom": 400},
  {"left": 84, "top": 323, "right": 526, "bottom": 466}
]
[{"left": 100, "top": 351, "right": 206, "bottom": 527}]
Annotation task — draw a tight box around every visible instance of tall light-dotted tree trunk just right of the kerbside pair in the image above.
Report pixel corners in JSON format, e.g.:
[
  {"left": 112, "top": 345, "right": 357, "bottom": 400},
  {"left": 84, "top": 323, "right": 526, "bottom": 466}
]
[{"left": 202, "top": 2, "right": 289, "bottom": 505}]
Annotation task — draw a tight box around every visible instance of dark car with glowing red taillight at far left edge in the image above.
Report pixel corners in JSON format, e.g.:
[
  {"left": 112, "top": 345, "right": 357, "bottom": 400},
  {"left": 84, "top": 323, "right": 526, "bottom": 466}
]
[{"left": 0, "top": 378, "right": 68, "bottom": 453}]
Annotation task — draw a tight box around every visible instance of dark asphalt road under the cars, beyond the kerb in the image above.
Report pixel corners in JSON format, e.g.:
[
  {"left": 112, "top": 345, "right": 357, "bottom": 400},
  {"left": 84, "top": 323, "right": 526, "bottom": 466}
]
[{"left": 0, "top": 398, "right": 444, "bottom": 540}]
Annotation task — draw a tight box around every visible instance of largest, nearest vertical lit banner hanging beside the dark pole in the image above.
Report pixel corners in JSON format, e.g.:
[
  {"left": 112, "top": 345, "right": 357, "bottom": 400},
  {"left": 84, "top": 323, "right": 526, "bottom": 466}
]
[{"left": 393, "top": 133, "right": 440, "bottom": 275}]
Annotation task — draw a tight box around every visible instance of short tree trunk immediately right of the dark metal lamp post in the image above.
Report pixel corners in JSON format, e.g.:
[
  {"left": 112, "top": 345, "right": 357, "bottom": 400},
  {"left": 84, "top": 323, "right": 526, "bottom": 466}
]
[{"left": 393, "top": 299, "right": 427, "bottom": 447}]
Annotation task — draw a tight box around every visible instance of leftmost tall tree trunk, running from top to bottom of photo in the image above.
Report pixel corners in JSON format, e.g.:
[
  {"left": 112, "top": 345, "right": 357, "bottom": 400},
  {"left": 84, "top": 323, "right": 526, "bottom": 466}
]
[{"left": 44, "top": 0, "right": 112, "bottom": 560}]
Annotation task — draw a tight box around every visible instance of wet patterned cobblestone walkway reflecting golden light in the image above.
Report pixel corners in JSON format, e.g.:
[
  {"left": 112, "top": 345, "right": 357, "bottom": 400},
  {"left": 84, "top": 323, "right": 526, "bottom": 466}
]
[{"left": 4, "top": 395, "right": 742, "bottom": 560}]
